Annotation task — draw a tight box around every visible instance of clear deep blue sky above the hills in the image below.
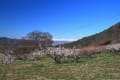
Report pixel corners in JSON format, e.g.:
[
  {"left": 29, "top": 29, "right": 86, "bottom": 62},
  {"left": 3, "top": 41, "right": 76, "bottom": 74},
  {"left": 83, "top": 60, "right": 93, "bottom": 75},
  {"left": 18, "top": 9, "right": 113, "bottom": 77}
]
[{"left": 0, "top": 0, "right": 120, "bottom": 40}]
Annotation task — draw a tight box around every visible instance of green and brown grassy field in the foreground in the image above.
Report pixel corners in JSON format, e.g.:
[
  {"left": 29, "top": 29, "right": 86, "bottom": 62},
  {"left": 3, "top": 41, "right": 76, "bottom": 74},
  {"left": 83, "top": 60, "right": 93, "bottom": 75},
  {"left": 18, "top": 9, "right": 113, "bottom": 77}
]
[{"left": 0, "top": 53, "right": 120, "bottom": 80}]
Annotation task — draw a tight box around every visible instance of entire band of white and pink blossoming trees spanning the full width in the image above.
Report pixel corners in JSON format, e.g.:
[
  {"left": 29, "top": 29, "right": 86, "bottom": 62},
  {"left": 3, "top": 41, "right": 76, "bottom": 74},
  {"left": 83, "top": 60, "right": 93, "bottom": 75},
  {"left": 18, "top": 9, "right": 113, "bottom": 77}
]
[{"left": 0, "top": 44, "right": 120, "bottom": 64}]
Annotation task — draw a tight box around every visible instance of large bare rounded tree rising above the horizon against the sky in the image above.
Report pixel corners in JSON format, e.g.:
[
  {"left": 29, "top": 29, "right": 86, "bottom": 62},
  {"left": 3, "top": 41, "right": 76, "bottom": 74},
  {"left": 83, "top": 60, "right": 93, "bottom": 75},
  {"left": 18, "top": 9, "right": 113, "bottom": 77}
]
[{"left": 25, "top": 31, "right": 52, "bottom": 48}]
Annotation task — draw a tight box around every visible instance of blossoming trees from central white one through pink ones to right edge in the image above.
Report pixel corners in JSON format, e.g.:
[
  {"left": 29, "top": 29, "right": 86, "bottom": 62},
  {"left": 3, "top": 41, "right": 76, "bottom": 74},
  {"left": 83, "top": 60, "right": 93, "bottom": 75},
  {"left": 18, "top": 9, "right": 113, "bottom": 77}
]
[{"left": 45, "top": 44, "right": 120, "bottom": 63}]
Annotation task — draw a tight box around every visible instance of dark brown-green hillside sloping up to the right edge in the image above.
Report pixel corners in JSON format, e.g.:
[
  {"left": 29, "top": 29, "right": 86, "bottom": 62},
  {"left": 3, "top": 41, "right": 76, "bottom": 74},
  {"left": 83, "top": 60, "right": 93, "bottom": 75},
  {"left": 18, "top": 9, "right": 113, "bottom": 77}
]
[{"left": 62, "top": 22, "right": 120, "bottom": 47}]
